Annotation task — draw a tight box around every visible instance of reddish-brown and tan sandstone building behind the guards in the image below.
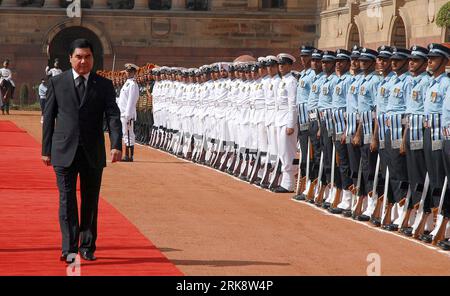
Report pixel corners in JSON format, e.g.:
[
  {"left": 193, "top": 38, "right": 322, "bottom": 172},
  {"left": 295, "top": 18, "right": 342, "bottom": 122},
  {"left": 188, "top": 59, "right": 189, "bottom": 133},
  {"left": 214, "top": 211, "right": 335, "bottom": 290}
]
[{"left": 0, "top": 0, "right": 450, "bottom": 92}]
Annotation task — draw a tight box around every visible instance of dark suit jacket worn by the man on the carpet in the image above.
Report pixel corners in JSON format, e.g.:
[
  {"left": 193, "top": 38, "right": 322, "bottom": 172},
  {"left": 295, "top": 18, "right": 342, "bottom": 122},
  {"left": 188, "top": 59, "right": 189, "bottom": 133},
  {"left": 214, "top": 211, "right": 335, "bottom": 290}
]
[{"left": 42, "top": 69, "right": 122, "bottom": 168}]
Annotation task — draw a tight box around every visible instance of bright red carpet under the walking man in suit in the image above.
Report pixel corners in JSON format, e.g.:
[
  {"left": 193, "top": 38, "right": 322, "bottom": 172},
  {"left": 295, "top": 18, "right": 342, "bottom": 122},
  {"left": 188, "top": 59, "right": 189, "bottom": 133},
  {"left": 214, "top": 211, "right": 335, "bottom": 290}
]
[{"left": 0, "top": 121, "right": 182, "bottom": 275}]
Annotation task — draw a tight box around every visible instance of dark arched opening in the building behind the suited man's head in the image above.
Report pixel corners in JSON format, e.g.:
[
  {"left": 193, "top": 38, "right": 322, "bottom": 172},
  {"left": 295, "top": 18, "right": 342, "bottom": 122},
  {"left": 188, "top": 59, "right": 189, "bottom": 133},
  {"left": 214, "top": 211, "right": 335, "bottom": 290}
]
[{"left": 48, "top": 26, "right": 103, "bottom": 71}]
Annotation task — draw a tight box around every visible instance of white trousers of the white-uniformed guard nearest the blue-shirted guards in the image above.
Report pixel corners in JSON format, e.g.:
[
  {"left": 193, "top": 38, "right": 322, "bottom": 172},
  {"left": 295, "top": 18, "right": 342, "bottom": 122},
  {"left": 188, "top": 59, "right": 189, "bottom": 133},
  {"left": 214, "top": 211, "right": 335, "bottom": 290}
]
[{"left": 277, "top": 125, "right": 298, "bottom": 191}]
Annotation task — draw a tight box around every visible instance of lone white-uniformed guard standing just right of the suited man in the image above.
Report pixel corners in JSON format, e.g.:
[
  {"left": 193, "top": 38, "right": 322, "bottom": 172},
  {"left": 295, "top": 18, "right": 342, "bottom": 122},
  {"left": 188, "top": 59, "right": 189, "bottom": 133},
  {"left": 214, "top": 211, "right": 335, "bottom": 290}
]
[{"left": 118, "top": 63, "right": 139, "bottom": 161}]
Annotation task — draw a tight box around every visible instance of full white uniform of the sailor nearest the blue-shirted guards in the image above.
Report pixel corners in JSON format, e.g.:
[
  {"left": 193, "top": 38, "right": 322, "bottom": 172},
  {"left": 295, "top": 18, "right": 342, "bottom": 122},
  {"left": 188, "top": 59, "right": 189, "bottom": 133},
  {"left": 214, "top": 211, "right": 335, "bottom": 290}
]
[{"left": 275, "top": 73, "right": 298, "bottom": 191}]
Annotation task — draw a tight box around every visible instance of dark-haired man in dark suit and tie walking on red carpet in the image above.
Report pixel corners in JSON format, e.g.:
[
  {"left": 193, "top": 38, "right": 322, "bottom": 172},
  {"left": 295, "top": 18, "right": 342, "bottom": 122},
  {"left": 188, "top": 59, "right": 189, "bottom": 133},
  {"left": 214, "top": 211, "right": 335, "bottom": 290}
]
[{"left": 42, "top": 39, "right": 122, "bottom": 263}]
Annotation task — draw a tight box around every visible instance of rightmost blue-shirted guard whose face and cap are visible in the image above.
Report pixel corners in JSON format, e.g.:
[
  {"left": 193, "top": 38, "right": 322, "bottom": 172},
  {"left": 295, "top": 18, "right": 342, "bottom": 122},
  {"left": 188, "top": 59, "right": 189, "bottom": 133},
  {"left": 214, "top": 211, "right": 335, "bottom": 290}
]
[{"left": 413, "top": 43, "right": 450, "bottom": 243}]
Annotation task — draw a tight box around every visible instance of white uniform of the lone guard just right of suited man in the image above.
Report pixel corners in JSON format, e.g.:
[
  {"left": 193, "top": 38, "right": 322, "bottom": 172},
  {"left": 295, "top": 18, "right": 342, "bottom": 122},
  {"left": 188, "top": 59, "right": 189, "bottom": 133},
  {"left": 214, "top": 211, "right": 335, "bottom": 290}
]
[{"left": 117, "top": 78, "right": 139, "bottom": 146}]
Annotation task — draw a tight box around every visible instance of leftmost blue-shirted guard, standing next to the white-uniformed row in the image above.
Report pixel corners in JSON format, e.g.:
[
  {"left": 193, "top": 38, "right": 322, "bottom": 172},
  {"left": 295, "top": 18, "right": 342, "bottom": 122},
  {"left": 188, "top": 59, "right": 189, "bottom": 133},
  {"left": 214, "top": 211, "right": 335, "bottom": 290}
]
[{"left": 294, "top": 45, "right": 316, "bottom": 200}]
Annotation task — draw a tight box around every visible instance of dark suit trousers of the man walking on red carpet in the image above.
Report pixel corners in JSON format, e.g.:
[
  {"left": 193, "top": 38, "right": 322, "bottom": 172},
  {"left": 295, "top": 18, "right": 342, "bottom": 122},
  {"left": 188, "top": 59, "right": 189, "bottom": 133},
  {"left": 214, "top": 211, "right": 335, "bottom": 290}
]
[{"left": 53, "top": 146, "right": 103, "bottom": 253}]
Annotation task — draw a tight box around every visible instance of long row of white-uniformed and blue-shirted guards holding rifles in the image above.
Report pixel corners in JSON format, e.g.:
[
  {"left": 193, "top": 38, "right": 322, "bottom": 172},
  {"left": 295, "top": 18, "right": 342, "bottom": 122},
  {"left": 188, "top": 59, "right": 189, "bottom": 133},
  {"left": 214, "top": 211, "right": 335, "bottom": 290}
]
[{"left": 102, "top": 44, "right": 450, "bottom": 250}]
